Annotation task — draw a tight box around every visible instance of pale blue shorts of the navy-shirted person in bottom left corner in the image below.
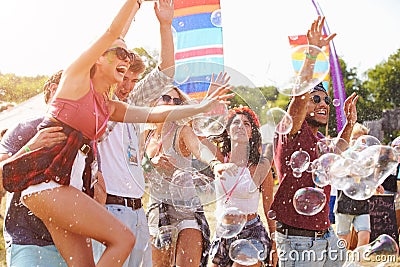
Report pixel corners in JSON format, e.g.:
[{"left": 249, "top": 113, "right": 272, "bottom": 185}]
[{"left": 6, "top": 244, "right": 67, "bottom": 267}]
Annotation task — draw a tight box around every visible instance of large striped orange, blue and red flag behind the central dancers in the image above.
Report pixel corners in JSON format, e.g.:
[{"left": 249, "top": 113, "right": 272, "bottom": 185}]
[{"left": 172, "top": 0, "right": 224, "bottom": 98}]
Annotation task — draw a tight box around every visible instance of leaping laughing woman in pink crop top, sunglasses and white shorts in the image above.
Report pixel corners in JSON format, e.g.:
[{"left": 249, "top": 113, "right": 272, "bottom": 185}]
[{"left": 0, "top": 0, "right": 230, "bottom": 267}]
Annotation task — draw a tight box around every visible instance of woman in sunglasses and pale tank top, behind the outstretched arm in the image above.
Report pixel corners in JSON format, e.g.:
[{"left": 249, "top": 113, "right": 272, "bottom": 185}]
[{"left": 144, "top": 75, "right": 228, "bottom": 267}]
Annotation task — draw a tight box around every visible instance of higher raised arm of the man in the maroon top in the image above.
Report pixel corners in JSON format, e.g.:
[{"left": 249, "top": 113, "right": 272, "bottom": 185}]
[{"left": 288, "top": 16, "right": 336, "bottom": 135}]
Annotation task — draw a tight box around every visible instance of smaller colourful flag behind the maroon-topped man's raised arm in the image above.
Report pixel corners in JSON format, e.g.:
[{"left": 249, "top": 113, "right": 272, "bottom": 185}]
[{"left": 289, "top": 35, "right": 330, "bottom": 92}]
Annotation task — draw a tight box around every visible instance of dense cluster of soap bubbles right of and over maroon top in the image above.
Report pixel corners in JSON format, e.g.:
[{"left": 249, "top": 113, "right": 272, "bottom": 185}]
[{"left": 288, "top": 135, "right": 398, "bottom": 216}]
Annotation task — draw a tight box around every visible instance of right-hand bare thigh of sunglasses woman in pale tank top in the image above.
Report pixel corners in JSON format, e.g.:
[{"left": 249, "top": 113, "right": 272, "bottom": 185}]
[{"left": 176, "top": 228, "right": 203, "bottom": 267}]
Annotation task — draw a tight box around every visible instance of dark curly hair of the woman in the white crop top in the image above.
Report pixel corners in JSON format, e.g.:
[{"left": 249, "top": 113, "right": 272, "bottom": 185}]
[{"left": 210, "top": 106, "right": 261, "bottom": 164}]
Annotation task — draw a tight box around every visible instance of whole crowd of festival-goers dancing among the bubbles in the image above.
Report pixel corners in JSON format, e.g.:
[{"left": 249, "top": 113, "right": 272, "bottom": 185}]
[{"left": 0, "top": 0, "right": 400, "bottom": 267}]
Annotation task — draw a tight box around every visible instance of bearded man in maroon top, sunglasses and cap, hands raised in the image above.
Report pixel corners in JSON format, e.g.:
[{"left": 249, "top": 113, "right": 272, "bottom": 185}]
[{"left": 271, "top": 17, "right": 358, "bottom": 267}]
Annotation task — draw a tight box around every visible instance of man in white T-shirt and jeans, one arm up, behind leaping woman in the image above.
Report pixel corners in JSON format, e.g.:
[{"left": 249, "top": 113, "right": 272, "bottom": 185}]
[{"left": 93, "top": 0, "right": 176, "bottom": 267}]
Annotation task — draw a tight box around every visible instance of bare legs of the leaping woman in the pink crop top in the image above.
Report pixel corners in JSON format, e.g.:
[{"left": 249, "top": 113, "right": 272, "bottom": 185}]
[{"left": 24, "top": 186, "right": 135, "bottom": 267}]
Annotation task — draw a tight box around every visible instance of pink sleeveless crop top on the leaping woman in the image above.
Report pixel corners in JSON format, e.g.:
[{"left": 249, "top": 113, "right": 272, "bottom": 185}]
[{"left": 48, "top": 81, "right": 110, "bottom": 140}]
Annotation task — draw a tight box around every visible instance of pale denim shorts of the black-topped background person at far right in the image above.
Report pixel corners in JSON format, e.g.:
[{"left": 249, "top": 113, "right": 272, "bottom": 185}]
[{"left": 335, "top": 213, "right": 371, "bottom": 235}]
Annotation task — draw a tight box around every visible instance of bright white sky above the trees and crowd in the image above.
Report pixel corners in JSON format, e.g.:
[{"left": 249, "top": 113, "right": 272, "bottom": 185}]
[{"left": 0, "top": 0, "right": 400, "bottom": 85}]
